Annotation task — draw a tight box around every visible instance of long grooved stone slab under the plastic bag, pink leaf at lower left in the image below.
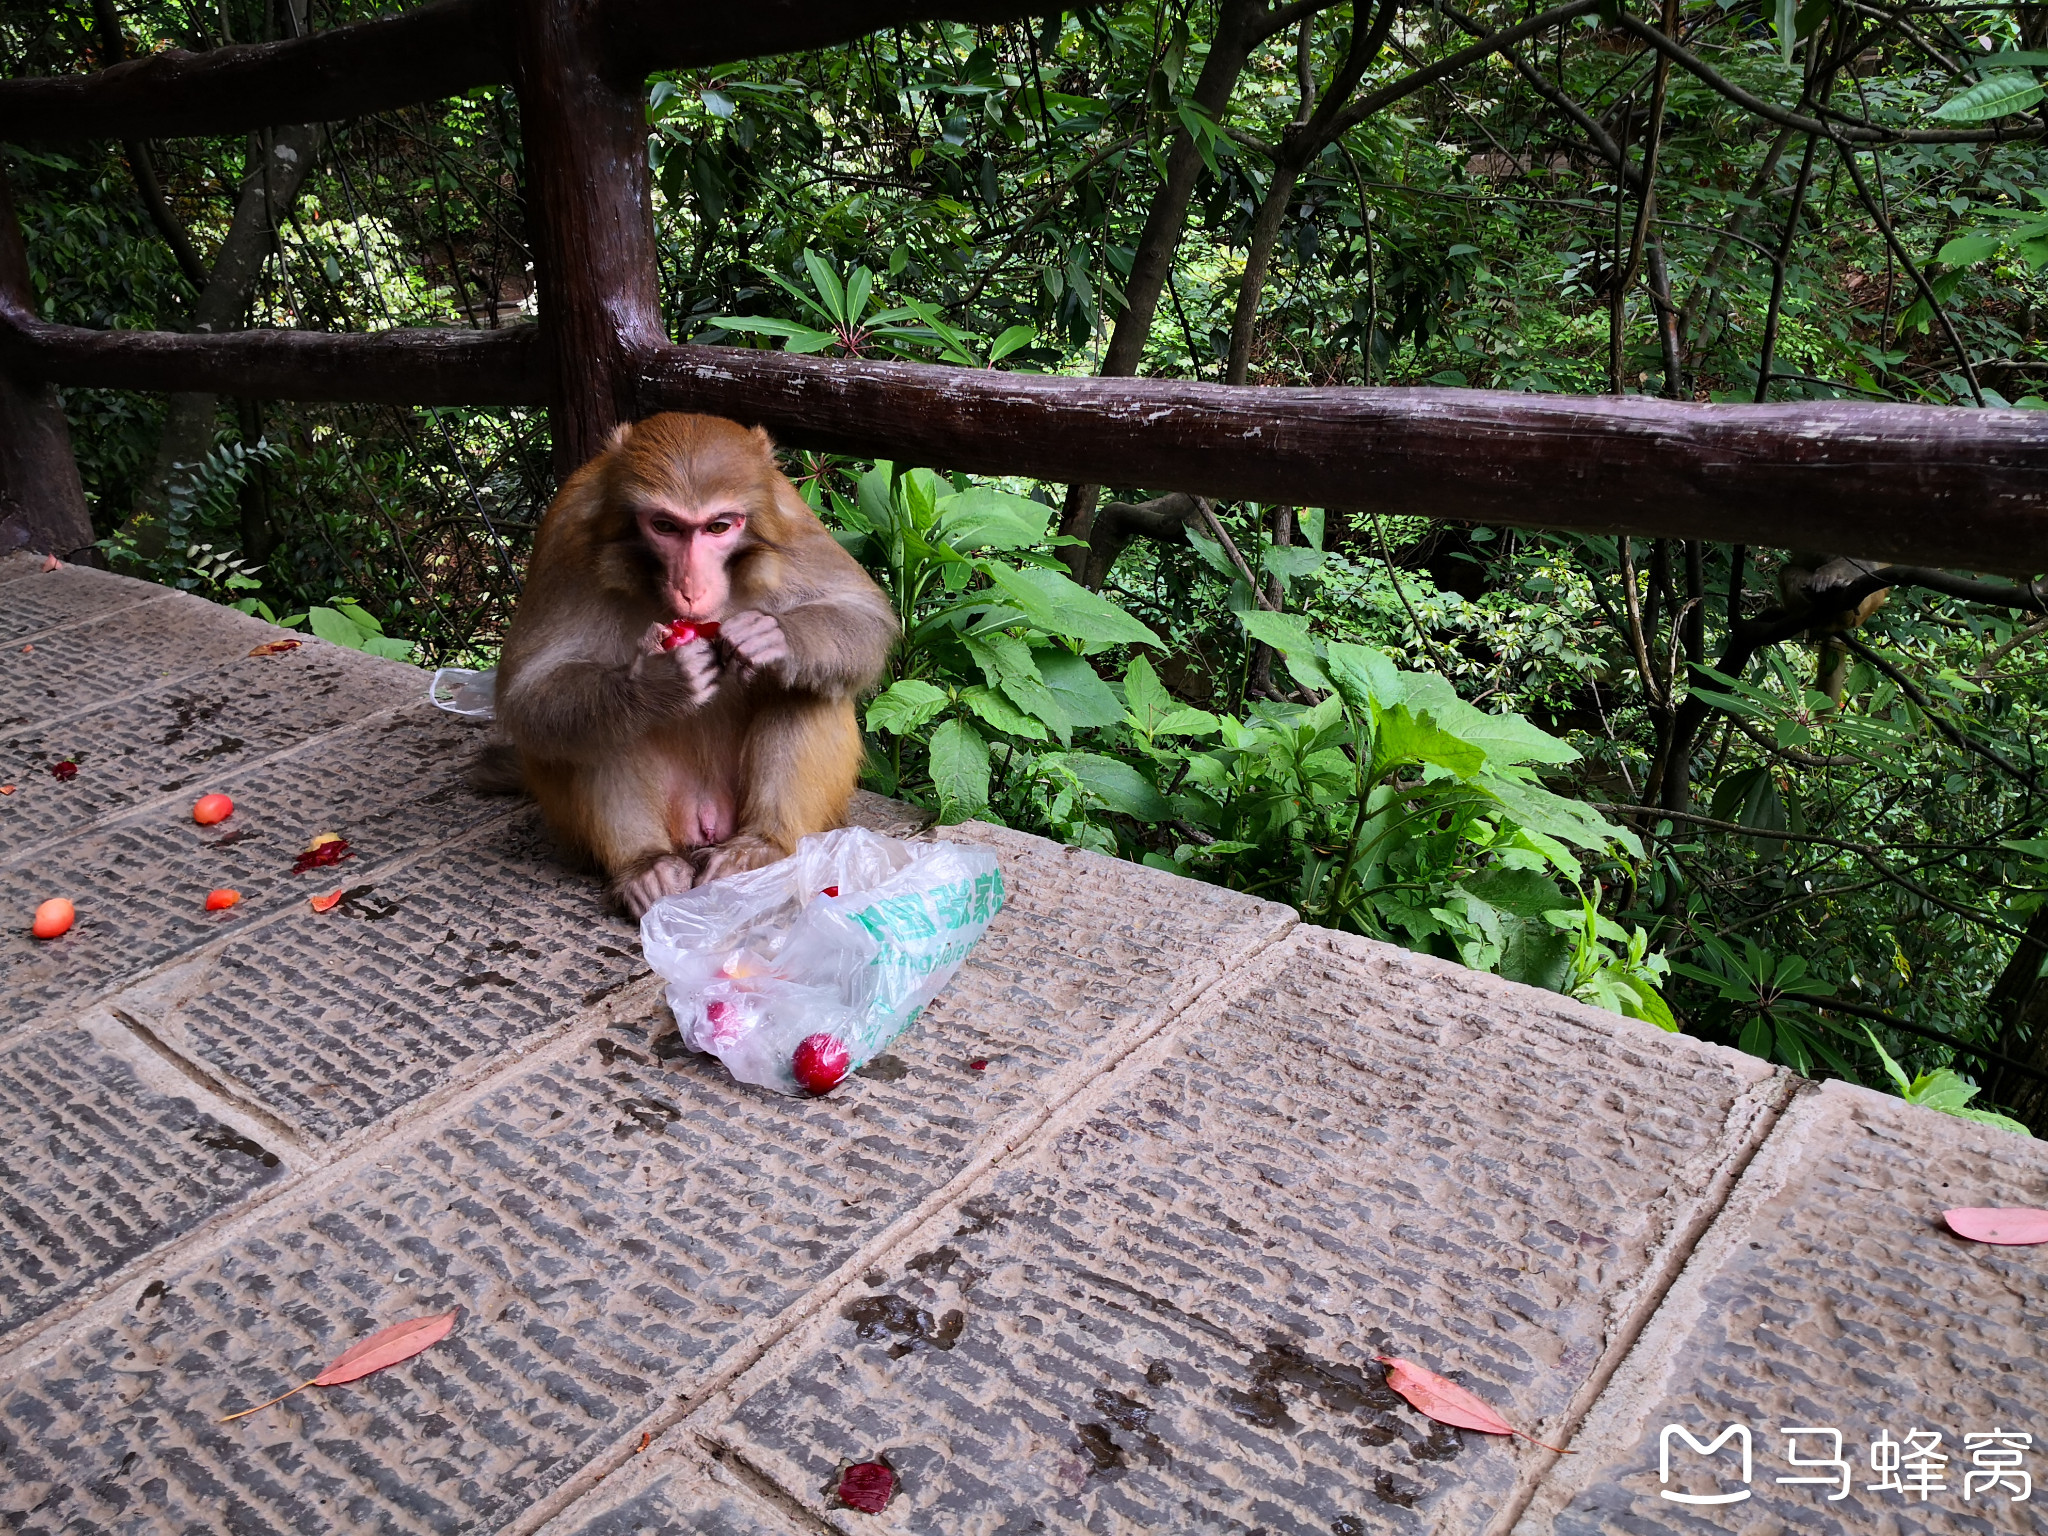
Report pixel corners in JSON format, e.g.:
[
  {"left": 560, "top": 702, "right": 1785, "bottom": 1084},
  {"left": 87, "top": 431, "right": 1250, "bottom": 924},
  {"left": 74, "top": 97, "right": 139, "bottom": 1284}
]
[{"left": 0, "top": 827, "right": 1288, "bottom": 1534}]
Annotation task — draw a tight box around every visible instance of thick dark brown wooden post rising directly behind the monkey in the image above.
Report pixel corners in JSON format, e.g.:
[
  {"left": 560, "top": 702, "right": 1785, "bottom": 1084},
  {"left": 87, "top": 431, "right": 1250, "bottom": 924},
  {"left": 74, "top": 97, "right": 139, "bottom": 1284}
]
[{"left": 516, "top": 0, "right": 668, "bottom": 479}]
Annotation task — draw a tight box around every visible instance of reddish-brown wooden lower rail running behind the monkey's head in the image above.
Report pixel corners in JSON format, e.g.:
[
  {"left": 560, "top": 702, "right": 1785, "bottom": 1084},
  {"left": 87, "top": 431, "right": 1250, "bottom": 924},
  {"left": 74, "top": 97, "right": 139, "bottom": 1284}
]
[{"left": 0, "top": 296, "right": 2048, "bottom": 575}]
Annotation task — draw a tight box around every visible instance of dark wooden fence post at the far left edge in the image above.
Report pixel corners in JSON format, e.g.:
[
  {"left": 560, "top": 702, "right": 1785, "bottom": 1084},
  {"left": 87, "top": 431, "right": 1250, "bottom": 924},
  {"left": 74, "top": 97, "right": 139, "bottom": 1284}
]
[{"left": 0, "top": 164, "right": 92, "bottom": 559}]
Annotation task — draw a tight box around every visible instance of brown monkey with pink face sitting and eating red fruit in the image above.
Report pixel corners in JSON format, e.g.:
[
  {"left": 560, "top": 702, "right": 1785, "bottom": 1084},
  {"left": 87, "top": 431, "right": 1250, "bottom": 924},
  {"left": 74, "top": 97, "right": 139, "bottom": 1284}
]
[{"left": 479, "top": 414, "right": 897, "bottom": 918}]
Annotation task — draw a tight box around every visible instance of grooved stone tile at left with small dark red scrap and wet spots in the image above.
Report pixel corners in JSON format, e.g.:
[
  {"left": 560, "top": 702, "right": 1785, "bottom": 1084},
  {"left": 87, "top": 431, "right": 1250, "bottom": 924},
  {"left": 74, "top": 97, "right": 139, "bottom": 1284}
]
[{"left": 0, "top": 625, "right": 426, "bottom": 862}]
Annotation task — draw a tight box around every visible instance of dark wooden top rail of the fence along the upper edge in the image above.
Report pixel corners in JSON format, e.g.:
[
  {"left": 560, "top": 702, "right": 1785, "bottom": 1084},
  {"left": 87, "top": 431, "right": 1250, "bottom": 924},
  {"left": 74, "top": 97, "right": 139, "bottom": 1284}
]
[{"left": 0, "top": 0, "right": 1055, "bottom": 139}]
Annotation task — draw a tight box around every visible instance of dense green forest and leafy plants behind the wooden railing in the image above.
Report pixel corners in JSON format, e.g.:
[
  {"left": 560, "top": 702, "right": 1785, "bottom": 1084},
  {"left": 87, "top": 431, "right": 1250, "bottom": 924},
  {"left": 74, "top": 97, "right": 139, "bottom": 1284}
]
[{"left": 0, "top": 0, "right": 2048, "bottom": 1133}]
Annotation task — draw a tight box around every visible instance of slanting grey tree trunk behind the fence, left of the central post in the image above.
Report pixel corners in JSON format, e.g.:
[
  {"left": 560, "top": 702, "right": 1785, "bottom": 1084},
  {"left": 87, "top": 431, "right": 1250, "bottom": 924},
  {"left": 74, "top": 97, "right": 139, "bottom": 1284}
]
[{"left": 129, "top": 123, "right": 324, "bottom": 555}]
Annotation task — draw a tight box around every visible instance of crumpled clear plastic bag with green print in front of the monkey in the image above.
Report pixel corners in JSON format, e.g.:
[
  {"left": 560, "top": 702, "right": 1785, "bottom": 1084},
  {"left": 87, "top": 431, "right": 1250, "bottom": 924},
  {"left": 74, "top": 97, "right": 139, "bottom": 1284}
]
[{"left": 641, "top": 827, "right": 1004, "bottom": 1094}]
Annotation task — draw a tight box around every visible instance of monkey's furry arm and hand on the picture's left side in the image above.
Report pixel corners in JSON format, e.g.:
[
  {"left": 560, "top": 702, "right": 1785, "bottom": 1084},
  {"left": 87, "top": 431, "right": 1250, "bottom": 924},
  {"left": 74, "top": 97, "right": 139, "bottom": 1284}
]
[{"left": 498, "top": 627, "right": 717, "bottom": 762}]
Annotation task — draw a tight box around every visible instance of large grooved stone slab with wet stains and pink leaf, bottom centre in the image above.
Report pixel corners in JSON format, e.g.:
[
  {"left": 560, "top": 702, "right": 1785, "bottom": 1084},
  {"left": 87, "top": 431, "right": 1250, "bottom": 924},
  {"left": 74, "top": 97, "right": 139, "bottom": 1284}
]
[{"left": 659, "top": 930, "right": 1778, "bottom": 1536}]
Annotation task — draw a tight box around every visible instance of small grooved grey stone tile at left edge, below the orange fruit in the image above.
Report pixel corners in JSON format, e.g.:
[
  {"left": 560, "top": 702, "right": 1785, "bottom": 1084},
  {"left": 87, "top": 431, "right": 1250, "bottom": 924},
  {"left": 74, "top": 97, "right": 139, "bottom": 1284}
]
[{"left": 0, "top": 1028, "right": 281, "bottom": 1335}]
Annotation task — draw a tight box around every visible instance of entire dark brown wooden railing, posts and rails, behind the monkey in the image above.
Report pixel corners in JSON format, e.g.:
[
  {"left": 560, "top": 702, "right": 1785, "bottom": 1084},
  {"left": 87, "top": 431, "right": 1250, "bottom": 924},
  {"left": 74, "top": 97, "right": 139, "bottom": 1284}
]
[{"left": 0, "top": 0, "right": 2048, "bottom": 575}]
